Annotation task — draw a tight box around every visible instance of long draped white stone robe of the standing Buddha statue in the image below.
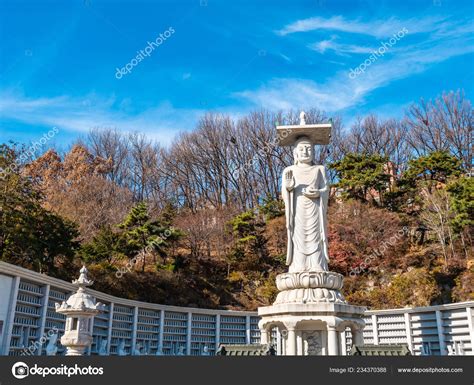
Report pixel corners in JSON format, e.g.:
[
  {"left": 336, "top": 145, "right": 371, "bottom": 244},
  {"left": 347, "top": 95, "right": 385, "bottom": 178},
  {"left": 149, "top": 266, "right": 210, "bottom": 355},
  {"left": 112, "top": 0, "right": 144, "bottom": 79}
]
[{"left": 282, "top": 165, "right": 329, "bottom": 273}]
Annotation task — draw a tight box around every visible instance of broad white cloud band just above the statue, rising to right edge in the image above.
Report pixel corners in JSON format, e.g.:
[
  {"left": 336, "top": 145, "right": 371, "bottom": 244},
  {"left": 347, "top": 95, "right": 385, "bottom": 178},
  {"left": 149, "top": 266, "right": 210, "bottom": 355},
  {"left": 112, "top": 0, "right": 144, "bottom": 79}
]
[{"left": 234, "top": 31, "right": 474, "bottom": 112}]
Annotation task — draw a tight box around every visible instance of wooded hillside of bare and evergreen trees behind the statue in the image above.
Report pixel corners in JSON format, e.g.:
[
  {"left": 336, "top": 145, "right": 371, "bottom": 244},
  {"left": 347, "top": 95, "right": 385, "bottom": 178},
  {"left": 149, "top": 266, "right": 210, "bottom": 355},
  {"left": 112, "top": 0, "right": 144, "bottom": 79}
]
[{"left": 0, "top": 91, "right": 474, "bottom": 310}]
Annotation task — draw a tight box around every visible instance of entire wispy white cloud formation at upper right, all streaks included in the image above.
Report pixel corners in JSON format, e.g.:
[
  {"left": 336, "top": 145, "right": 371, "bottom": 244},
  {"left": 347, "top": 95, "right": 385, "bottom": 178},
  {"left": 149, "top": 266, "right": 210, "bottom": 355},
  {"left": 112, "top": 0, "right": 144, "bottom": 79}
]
[{"left": 239, "top": 16, "right": 474, "bottom": 112}]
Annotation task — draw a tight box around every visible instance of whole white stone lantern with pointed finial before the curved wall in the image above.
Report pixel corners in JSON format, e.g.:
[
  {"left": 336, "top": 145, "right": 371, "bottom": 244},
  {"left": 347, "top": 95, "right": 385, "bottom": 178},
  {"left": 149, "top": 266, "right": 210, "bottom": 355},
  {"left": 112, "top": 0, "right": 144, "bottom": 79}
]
[{"left": 56, "top": 266, "right": 105, "bottom": 356}]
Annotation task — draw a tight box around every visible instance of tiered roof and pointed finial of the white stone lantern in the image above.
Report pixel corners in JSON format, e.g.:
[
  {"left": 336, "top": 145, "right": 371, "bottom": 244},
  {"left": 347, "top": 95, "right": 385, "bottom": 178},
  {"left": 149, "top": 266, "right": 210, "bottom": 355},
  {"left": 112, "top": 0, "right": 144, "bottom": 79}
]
[{"left": 56, "top": 266, "right": 105, "bottom": 314}]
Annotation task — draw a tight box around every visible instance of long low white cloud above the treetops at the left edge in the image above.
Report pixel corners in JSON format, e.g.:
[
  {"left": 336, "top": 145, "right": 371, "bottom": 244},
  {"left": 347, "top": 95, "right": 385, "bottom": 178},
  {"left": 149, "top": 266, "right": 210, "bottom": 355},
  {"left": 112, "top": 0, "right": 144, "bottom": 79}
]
[{"left": 0, "top": 92, "right": 204, "bottom": 144}]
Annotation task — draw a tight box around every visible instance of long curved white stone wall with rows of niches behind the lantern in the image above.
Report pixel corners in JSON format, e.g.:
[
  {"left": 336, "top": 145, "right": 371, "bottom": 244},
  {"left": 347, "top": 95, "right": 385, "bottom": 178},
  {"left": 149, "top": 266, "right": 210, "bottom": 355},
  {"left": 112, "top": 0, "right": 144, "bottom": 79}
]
[{"left": 0, "top": 262, "right": 474, "bottom": 355}]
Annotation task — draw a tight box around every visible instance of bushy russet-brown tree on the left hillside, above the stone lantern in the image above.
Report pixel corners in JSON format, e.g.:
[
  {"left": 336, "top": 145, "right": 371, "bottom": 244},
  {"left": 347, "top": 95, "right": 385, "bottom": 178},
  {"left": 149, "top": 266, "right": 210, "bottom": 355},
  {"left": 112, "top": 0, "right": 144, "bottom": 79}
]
[{"left": 26, "top": 145, "right": 132, "bottom": 241}]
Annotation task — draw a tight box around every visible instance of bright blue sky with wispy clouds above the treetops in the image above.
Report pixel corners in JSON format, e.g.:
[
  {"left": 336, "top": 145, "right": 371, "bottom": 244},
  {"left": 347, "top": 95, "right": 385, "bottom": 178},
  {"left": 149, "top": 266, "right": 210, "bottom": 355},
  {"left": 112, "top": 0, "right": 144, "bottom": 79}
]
[{"left": 0, "top": 0, "right": 474, "bottom": 146}]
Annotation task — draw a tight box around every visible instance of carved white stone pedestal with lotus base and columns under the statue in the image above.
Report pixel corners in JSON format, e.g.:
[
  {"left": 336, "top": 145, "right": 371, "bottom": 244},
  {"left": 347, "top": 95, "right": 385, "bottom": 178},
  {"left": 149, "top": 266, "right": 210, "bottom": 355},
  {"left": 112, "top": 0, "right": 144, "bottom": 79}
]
[{"left": 258, "top": 271, "right": 365, "bottom": 356}]
